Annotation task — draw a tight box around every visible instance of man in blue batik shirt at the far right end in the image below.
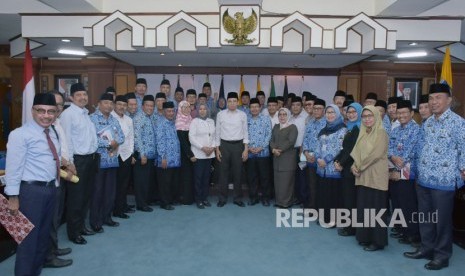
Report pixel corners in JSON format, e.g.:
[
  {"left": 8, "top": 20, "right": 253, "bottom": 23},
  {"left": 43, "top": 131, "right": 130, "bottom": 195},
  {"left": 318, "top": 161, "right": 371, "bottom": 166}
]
[{"left": 404, "top": 83, "right": 465, "bottom": 270}]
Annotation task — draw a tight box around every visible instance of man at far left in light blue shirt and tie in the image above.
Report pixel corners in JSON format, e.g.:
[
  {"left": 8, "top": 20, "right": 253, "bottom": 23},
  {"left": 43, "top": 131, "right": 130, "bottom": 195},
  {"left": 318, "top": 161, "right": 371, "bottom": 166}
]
[{"left": 5, "top": 93, "right": 60, "bottom": 275}]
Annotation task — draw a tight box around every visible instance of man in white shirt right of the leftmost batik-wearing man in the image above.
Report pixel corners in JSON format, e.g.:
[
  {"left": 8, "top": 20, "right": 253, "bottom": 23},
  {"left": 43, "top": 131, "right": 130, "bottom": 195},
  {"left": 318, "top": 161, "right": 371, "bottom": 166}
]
[{"left": 111, "top": 95, "right": 136, "bottom": 219}]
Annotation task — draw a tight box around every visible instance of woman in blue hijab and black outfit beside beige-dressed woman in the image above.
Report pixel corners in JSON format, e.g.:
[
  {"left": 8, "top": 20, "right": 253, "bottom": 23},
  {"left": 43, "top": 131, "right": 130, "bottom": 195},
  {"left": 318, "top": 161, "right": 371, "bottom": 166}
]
[{"left": 334, "top": 103, "right": 363, "bottom": 236}]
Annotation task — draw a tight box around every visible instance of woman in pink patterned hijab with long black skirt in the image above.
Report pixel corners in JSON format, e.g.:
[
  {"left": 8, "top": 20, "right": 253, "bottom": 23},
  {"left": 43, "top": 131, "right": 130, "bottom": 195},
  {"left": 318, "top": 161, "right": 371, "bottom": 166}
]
[{"left": 175, "top": 101, "right": 197, "bottom": 205}]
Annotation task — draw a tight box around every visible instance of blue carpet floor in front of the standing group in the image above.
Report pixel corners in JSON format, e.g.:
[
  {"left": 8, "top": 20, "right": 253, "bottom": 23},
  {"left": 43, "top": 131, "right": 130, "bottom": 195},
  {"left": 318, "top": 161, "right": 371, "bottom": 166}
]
[{"left": 0, "top": 197, "right": 465, "bottom": 276}]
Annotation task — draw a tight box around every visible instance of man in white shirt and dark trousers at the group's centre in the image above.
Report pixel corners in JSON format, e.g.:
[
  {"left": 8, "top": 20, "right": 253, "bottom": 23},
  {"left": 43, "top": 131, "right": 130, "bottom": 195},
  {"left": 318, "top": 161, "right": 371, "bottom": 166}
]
[{"left": 216, "top": 92, "right": 249, "bottom": 207}]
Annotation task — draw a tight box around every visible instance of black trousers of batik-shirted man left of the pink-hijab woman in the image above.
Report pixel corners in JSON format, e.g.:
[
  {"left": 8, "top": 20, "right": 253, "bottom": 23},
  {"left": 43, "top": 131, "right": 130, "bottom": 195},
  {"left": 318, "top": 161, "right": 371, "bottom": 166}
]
[{"left": 157, "top": 167, "right": 179, "bottom": 207}]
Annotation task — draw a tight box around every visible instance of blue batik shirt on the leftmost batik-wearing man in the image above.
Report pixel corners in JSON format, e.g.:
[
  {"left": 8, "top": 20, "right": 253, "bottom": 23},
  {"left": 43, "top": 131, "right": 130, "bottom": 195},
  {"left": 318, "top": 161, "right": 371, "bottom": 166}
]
[{"left": 90, "top": 109, "right": 124, "bottom": 169}]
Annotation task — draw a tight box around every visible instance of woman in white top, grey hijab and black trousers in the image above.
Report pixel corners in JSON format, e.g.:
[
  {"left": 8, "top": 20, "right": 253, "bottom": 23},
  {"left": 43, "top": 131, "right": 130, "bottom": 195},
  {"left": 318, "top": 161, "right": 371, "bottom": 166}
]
[{"left": 189, "top": 104, "right": 216, "bottom": 209}]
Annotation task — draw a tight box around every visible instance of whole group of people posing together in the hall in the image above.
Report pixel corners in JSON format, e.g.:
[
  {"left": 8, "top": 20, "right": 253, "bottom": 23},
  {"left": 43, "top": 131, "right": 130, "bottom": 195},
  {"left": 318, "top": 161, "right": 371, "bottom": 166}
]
[{"left": 5, "top": 78, "right": 465, "bottom": 275}]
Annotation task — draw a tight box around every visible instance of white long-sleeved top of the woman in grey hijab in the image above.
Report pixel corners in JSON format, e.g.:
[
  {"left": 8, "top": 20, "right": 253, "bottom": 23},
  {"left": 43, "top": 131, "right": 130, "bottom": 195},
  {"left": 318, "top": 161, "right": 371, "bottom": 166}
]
[{"left": 189, "top": 118, "right": 217, "bottom": 159}]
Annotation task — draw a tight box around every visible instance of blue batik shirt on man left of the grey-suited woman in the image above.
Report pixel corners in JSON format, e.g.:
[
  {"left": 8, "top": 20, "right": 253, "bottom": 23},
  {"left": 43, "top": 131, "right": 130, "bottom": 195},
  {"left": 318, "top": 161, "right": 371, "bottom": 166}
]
[{"left": 247, "top": 114, "right": 271, "bottom": 158}]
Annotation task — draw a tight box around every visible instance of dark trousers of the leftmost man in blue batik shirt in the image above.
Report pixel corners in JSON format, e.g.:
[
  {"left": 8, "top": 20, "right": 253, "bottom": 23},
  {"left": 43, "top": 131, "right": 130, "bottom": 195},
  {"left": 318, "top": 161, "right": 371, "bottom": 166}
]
[{"left": 89, "top": 168, "right": 117, "bottom": 227}]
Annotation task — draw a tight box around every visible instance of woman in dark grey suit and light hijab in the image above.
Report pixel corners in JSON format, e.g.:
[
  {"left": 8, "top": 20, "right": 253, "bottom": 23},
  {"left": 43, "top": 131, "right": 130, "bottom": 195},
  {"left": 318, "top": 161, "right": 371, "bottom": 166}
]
[{"left": 270, "top": 108, "right": 297, "bottom": 208}]
